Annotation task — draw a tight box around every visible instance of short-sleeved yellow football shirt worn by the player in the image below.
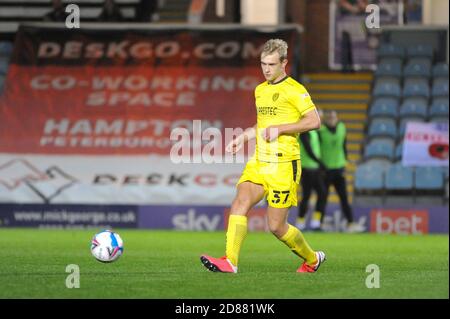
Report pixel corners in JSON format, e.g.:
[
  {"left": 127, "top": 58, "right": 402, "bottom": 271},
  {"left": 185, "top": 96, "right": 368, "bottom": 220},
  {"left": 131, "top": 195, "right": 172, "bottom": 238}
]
[{"left": 255, "top": 77, "right": 315, "bottom": 162}]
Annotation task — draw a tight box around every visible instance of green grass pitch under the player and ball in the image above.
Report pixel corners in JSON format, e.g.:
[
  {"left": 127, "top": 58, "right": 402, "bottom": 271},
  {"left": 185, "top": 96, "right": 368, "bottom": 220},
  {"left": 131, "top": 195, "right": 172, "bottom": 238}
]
[{"left": 0, "top": 229, "right": 449, "bottom": 299}]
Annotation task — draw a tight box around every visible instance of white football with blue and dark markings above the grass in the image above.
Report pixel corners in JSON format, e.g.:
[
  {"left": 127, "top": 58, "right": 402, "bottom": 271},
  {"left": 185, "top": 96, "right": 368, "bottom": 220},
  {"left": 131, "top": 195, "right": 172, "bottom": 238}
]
[{"left": 91, "top": 230, "right": 123, "bottom": 263}]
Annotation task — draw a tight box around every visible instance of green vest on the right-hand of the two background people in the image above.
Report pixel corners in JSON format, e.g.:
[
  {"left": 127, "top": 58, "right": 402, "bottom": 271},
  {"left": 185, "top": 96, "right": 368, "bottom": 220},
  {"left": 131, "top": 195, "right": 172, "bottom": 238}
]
[{"left": 319, "top": 122, "right": 347, "bottom": 169}]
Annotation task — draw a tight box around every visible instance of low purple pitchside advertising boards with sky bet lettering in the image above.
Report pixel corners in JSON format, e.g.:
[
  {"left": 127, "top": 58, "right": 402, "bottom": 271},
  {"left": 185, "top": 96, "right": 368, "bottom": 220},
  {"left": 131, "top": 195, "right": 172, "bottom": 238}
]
[{"left": 0, "top": 204, "right": 449, "bottom": 235}]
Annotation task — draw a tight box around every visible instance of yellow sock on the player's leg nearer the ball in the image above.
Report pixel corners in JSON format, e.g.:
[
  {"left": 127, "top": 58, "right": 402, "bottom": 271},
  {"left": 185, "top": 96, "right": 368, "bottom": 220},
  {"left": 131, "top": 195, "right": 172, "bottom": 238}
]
[{"left": 226, "top": 215, "right": 247, "bottom": 266}]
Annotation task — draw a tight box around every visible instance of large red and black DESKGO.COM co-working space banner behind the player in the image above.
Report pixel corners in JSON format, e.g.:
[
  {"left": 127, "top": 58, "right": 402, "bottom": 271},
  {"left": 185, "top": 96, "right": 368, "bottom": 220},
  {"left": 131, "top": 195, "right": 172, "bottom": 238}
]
[{"left": 0, "top": 26, "right": 298, "bottom": 155}]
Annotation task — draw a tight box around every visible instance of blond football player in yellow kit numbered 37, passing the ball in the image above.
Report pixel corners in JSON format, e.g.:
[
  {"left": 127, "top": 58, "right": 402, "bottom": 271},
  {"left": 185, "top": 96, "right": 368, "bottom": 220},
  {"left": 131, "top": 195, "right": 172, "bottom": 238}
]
[{"left": 200, "top": 39, "right": 325, "bottom": 273}]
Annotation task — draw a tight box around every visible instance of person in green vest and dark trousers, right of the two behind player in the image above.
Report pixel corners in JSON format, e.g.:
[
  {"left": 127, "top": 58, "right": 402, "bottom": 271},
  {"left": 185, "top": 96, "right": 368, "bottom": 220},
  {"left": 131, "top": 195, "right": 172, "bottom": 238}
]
[{"left": 319, "top": 111, "right": 364, "bottom": 232}]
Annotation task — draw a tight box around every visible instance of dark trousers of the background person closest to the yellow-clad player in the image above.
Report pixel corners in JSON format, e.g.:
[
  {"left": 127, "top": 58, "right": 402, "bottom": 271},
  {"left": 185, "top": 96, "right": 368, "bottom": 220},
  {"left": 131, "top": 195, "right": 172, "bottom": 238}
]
[{"left": 298, "top": 168, "right": 327, "bottom": 220}]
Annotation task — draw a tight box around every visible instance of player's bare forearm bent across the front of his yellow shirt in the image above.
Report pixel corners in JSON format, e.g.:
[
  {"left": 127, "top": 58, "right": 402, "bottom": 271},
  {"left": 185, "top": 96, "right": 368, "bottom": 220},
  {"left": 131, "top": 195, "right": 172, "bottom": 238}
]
[{"left": 261, "top": 108, "right": 320, "bottom": 142}]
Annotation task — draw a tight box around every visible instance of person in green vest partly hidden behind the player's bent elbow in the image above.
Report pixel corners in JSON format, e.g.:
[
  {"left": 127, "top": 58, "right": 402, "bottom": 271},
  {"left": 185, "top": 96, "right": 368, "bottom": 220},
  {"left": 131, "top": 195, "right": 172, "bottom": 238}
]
[{"left": 296, "top": 128, "right": 327, "bottom": 231}]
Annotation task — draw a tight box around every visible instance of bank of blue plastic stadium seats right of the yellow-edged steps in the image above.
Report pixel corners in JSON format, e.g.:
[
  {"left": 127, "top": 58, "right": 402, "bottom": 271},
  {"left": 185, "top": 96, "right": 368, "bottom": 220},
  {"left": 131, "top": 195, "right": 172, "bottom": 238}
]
[{"left": 360, "top": 39, "right": 449, "bottom": 203}]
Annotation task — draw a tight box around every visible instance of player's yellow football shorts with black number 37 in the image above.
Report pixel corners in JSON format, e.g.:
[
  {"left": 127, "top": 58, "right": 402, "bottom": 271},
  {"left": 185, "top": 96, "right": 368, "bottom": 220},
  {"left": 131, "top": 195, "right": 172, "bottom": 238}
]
[{"left": 237, "top": 158, "right": 302, "bottom": 208}]
